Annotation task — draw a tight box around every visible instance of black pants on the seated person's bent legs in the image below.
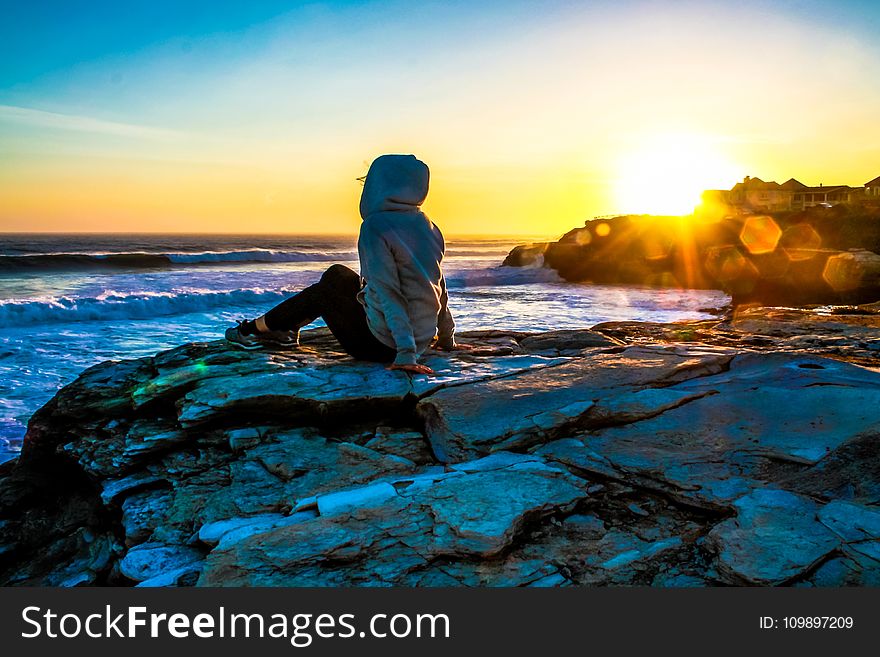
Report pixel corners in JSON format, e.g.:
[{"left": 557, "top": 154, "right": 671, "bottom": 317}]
[{"left": 265, "top": 265, "right": 397, "bottom": 363}]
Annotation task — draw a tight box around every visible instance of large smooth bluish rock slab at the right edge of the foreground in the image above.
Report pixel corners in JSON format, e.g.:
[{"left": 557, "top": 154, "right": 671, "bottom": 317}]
[{"left": 537, "top": 353, "right": 880, "bottom": 508}]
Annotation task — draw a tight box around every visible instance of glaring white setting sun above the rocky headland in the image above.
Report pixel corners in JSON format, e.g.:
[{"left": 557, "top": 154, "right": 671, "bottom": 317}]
[{"left": 614, "top": 134, "right": 739, "bottom": 215}]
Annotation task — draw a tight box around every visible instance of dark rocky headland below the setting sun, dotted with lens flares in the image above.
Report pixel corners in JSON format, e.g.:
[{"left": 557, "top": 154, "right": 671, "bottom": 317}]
[{"left": 504, "top": 214, "right": 880, "bottom": 305}]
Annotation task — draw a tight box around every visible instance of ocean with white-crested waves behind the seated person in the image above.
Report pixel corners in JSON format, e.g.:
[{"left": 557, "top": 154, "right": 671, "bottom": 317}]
[{"left": 0, "top": 234, "right": 729, "bottom": 462}]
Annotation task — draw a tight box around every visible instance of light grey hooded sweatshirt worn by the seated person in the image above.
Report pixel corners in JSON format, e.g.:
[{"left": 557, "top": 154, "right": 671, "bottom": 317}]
[{"left": 358, "top": 155, "right": 455, "bottom": 365}]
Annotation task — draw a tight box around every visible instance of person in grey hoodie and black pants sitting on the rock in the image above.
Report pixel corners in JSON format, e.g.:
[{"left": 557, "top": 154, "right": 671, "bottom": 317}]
[{"left": 226, "top": 155, "right": 456, "bottom": 374}]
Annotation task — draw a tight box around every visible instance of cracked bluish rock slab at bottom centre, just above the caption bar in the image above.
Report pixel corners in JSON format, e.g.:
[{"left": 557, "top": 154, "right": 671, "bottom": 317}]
[{"left": 200, "top": 455, "right": 586, "bottom": 586}]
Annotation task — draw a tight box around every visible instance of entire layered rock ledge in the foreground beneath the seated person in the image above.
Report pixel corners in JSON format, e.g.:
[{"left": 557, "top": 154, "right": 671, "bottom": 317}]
[{"left": 0, "top": 304, "right": 880, "bottom": 586}]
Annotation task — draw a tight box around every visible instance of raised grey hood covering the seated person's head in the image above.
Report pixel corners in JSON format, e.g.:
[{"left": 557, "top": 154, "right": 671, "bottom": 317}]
[{"left": 360, "top": 155, "right": 429, "bottom": 219}]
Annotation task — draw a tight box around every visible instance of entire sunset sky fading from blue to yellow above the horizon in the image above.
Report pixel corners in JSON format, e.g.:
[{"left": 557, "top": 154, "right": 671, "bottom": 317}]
[{"left": 0, "top": 0, "right": 880, "bottom": 235}]
